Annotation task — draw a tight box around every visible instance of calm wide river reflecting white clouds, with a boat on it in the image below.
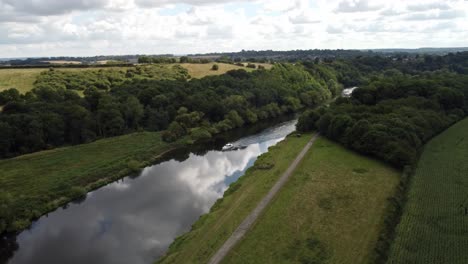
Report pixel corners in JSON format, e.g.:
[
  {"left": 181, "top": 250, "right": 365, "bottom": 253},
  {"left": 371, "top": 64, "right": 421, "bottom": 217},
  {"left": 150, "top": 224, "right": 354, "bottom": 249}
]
[{"left": 0, "top": 120, "right": 296, "bottom": 264}]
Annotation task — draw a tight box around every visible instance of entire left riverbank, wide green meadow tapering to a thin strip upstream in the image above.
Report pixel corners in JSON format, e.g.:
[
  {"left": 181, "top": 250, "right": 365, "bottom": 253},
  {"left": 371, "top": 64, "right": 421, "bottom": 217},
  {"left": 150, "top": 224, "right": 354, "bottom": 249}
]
[{"left": 0, "top": 115, "right": 294, "bottom": 234}]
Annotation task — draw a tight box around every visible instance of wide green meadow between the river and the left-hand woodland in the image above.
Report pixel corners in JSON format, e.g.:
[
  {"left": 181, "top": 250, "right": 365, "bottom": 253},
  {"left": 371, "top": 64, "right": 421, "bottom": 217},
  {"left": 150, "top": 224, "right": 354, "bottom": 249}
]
[{"left": 0, "top": 132, "right": 180, "bottom": 233}]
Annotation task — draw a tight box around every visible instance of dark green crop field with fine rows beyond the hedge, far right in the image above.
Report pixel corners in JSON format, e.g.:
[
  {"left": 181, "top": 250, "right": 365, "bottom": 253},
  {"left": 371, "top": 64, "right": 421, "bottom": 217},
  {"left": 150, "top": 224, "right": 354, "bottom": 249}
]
[{"left": 388, "top": 119, "right": 468, "bottom": 264}]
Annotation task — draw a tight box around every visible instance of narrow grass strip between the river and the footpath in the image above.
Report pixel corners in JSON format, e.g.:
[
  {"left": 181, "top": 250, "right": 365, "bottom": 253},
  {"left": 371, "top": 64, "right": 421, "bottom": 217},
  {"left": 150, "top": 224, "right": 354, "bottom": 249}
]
[{"left": 160, "top": 135, "right": 311, "bottom": 263}]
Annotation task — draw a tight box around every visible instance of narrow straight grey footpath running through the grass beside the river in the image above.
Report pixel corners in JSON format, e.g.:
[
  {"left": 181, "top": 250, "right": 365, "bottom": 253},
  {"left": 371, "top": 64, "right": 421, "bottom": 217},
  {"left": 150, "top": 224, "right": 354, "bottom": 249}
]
[{"left": 208, "top": 133, "right": 319, "bottom": 264}]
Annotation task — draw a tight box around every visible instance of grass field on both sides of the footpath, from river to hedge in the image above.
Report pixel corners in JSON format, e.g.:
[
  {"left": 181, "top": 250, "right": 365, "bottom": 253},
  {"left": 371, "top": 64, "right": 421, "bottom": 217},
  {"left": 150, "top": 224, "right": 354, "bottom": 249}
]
[{"left": 161, "top": 135, "right": 399, "bottom": 263}]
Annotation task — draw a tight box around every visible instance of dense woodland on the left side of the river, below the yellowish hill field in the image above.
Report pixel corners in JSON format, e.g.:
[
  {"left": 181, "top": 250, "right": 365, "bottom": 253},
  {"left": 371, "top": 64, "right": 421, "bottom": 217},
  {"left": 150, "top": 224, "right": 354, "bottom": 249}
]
[{"left": 0, "top": 64, "right": 339, "bottom": 158}]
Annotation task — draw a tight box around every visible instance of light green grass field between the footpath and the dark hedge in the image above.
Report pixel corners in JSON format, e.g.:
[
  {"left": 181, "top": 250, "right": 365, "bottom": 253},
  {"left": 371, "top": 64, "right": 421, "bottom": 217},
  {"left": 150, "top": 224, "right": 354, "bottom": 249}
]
[{"left": 223, "top": 138, "right": 400, "bottom": 264}]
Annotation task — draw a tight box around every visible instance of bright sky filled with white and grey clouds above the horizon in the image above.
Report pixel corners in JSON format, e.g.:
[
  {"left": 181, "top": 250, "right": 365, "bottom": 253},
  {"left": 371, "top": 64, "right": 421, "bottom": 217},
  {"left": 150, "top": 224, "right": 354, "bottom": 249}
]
[{"left": 0, "top": 0, "right": 468, "bottom": 58}]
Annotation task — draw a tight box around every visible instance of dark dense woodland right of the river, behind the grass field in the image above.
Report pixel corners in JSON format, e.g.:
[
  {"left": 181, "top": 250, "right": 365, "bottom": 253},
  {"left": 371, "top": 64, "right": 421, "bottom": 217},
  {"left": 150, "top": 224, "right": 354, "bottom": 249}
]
[{"left": 298, "top": 62, "right": 468, "bottom": 168}]
